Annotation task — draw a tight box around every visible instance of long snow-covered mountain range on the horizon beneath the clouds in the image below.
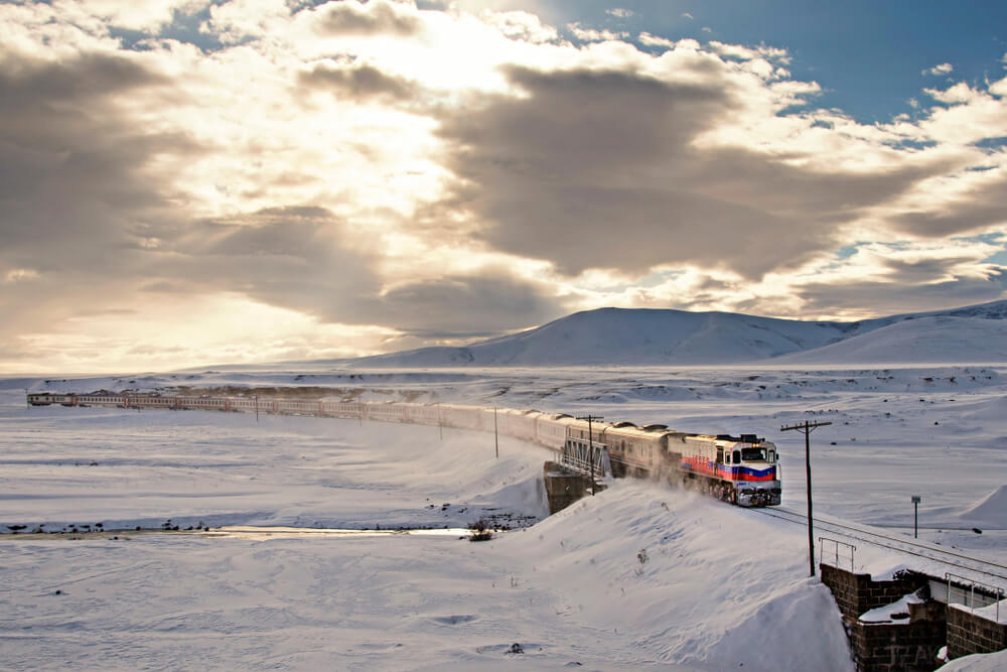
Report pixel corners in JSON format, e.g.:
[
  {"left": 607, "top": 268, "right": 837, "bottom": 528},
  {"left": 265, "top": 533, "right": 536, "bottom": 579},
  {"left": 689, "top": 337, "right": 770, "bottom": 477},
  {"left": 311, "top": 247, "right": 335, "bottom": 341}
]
[{"left": 353, "top": 300, "right": 1007, "bottom": 367}]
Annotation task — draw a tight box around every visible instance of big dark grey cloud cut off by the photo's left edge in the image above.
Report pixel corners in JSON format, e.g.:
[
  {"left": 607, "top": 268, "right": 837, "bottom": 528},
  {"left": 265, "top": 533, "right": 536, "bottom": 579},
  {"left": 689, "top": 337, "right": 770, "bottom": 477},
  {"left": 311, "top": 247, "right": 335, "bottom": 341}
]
[{"left": 0, "top": 49, "right": 183, "bottom": 259}]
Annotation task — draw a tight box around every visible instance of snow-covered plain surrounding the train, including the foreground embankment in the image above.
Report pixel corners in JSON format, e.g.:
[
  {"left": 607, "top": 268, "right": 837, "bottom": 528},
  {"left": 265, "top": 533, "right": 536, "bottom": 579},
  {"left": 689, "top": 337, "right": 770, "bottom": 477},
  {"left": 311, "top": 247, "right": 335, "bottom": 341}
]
[{"left": 0, "top": 366, "right": 1007, "bottom": 672}]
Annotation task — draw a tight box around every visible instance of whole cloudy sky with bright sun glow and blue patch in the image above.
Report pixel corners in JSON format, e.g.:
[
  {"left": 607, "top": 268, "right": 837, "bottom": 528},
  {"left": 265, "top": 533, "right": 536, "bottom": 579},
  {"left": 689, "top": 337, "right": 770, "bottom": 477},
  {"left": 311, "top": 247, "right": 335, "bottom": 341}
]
[{"left": 0, "top": 0, "right": 1007, "bottom": 374}]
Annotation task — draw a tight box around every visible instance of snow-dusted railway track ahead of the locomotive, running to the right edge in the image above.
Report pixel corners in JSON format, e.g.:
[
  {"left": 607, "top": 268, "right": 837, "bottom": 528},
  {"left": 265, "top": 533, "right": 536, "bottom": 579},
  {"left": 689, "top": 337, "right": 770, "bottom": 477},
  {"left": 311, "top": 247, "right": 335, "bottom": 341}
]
[{"left": 749, "top": 507, "right": 1007, "bottom": 587}]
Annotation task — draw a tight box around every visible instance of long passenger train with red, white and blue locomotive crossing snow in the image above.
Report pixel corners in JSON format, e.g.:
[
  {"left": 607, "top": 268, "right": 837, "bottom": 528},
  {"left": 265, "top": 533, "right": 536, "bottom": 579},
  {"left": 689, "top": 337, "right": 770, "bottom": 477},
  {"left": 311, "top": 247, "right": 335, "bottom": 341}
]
[{"left": 27, "top": 391, "right": 782, "bottom": 507}]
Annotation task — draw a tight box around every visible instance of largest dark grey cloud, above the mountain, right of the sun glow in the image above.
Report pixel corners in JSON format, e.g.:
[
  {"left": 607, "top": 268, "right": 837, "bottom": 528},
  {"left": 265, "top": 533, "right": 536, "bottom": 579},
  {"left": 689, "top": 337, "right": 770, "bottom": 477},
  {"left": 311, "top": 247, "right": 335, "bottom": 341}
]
[{"left": 442, "top": 60, "right": 937, "bottom": 278}]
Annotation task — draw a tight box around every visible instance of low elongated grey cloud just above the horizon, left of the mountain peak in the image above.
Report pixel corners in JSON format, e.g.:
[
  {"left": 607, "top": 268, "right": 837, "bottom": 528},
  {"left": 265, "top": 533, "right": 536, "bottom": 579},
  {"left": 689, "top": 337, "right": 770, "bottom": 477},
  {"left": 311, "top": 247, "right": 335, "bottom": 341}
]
[{"left": 168, "top": 208, "right": 561, "bottom": 339}]
